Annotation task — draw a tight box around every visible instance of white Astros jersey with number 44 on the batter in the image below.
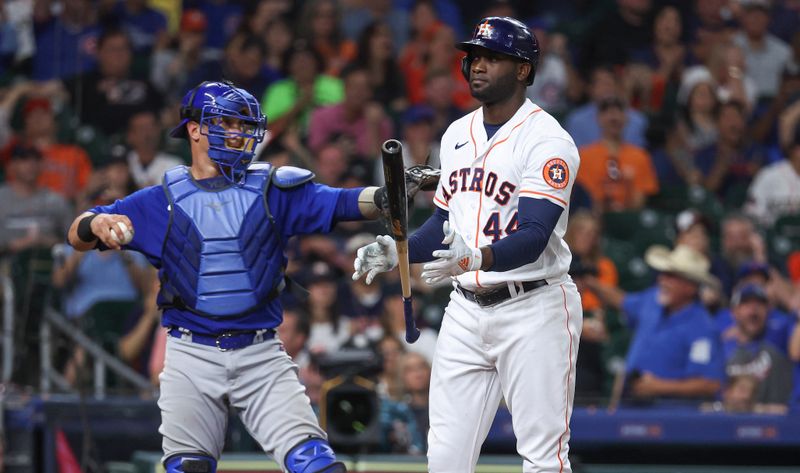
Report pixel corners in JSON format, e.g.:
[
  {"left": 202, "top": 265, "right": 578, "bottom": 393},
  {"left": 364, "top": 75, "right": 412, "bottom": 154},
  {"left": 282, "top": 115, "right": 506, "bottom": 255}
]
[{"left": 434, "top": 99, "right": 580, "bottom": 290}]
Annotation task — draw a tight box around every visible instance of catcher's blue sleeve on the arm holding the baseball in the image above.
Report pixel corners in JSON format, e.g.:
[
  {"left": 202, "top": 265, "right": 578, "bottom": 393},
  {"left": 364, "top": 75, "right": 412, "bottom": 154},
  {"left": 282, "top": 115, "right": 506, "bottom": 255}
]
[{"left": 89, "top": 186, "right": 169, "bottom": 267}]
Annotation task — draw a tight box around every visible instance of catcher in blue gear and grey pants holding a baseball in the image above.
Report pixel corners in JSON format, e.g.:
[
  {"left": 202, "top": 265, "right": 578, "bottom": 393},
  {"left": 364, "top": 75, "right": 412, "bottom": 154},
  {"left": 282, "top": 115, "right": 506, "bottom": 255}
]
[{"left": 69, "top": 82, "right": 434, "bottom": 473}]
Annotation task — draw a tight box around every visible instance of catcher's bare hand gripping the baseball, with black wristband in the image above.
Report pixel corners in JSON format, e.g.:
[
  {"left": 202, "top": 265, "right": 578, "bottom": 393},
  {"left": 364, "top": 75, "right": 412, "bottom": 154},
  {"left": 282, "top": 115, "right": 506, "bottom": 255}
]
[{"left": 67, "top": 212, "right": 133, "bottom": 251}]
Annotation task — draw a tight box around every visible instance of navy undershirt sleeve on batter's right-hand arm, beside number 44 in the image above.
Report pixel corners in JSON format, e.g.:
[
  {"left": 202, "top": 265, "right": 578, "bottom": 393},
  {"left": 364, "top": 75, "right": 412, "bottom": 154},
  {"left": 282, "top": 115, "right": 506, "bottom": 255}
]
[{"left": 487, "top": 197, "right": 564, "bottom": 271}]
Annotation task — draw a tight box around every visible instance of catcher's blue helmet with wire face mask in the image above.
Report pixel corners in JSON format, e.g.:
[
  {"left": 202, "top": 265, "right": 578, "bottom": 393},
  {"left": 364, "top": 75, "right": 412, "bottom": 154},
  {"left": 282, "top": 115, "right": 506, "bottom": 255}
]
[{"left": 170, "top": 82, "right": 267, "bottom": 183}]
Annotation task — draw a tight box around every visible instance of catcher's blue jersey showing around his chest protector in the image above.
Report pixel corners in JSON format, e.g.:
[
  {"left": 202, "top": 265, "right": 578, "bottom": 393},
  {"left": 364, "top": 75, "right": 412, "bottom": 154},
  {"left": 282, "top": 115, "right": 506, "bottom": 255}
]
[{"left": 89, "top": 177, "right": 357, "bottom": 334}]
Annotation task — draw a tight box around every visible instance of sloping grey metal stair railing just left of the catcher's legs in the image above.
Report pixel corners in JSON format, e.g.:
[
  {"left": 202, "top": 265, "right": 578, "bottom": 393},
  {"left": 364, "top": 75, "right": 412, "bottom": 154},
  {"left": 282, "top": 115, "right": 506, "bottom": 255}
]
[{"left": 39, "top": 307, "right": 157, "bottom": 399}]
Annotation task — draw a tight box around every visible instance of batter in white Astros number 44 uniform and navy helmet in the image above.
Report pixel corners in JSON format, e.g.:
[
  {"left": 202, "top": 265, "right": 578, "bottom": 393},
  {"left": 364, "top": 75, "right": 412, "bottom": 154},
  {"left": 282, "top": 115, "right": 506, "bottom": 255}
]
[{"left": 353, "top": 17, "right": 582, "bottom": 473}]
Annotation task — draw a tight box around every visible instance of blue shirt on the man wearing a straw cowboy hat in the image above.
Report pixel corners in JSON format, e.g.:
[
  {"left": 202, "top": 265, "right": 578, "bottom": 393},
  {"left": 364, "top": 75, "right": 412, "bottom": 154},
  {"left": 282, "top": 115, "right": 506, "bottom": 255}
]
[{"left": 622, "top": 286, "right": 725, "bottom": 381}]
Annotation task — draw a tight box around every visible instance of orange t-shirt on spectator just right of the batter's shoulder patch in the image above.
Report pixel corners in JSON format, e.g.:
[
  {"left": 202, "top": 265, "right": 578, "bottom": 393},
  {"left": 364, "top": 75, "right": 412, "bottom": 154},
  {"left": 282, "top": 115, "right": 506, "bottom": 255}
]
[{"left": 578, "top": 141, "right": 658, "bottom": 208}]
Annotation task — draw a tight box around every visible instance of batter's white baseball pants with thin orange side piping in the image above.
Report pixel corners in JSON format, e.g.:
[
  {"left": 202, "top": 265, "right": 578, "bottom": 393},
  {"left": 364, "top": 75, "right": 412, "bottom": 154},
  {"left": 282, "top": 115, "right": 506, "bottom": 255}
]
[{"left": 428, "top": 278, "right": 583, "bottom": 473}]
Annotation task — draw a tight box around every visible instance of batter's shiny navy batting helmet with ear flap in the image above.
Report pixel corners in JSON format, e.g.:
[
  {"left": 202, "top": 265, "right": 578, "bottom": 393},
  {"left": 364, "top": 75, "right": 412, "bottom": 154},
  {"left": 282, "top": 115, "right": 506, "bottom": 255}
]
[{"left": 456, "top": 16, "right": 539, "bottom": 85}]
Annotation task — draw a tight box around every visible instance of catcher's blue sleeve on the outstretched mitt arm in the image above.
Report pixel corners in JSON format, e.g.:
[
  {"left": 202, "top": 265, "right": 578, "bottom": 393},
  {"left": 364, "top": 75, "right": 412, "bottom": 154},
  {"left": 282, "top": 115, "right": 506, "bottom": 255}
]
[{"left": 268, "top": 182, "right": 356, "bottom": 238}]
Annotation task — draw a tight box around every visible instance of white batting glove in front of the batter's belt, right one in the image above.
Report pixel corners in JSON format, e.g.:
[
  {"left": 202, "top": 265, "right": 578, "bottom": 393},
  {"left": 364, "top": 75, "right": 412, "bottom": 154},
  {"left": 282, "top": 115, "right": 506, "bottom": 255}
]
[{"left": 422, "top": 222, "right": 483, "bottom": 284}]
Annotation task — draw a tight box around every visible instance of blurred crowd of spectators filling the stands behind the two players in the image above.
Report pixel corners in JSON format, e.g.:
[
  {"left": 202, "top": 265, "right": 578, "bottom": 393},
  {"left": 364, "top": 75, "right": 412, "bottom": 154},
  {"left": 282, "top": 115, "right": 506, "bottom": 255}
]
[{"left": 0, "top": 0, "right": 800, "bottom": 453}]
